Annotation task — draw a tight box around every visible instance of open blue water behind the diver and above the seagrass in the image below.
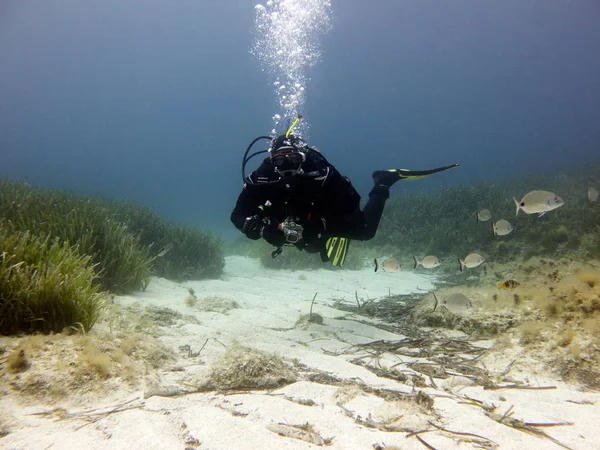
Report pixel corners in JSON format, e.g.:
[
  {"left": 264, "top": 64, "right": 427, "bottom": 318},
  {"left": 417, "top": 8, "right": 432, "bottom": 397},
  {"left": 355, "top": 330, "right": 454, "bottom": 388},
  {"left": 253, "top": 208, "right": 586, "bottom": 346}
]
[{"left": 0, "top": 0, "right": 600, "bottom": 243}]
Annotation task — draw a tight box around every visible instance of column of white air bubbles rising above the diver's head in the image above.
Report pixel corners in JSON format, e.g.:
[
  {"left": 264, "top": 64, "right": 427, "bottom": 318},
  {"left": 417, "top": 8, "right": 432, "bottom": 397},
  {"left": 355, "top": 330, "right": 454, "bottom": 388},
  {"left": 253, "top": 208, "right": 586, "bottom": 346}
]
[{"left": 252, "top": 0, "right": 332, "bottom": 135}]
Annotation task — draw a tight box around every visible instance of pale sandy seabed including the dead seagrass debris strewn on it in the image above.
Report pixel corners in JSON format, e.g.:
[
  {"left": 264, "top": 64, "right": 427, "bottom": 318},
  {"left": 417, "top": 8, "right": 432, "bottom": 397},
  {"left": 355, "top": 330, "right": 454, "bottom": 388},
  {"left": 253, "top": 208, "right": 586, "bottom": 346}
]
[{"left": 0, "top": 256, "right": 600, "bottom": 450}]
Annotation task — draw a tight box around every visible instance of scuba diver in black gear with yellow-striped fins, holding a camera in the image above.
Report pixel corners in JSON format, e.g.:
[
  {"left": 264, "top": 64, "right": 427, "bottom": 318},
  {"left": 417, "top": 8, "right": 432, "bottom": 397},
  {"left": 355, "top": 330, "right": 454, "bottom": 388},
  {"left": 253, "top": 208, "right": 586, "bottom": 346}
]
[{"left": 231, "top": 115, "right": 458, "bottom": 266}]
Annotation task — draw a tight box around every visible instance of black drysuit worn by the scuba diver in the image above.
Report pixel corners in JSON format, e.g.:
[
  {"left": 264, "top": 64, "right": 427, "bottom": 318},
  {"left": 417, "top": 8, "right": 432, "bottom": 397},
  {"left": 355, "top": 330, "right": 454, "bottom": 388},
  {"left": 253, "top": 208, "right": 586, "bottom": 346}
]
[{"left": 231, "top": 148, "right": 389, "bottom": 255}]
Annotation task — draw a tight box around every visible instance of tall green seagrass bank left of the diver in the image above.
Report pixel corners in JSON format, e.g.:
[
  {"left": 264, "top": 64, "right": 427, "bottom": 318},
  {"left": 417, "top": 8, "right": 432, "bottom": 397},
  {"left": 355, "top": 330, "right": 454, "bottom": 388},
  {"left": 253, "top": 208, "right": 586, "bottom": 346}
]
[{"left": 0, "top": 180, "right": 225, "bottom": 334}]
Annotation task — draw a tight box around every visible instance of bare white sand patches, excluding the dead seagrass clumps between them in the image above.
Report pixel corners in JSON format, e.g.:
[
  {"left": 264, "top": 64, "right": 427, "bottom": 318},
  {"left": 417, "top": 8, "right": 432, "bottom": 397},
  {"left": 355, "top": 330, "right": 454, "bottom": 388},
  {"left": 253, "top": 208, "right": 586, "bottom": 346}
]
[{"left": 0, "top": 257, "right": 600, "bottom": 450}]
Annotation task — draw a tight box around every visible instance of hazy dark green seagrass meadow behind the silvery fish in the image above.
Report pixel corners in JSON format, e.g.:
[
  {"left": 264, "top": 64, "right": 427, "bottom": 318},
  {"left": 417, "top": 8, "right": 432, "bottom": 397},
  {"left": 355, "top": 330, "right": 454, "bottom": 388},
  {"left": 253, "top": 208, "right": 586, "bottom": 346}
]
[{"left": 376, "top": 165, "right": 600, "bottom": 266}]
